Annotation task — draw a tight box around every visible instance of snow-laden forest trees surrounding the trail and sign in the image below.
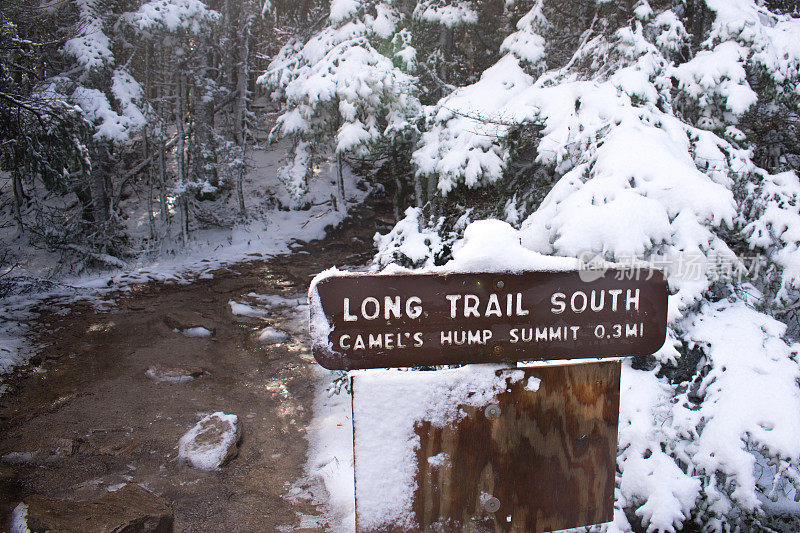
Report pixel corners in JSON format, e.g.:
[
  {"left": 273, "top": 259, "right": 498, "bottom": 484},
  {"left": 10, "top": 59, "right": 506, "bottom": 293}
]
[{"left": 0, "top": 0, "right": 800, "bottom": 531}]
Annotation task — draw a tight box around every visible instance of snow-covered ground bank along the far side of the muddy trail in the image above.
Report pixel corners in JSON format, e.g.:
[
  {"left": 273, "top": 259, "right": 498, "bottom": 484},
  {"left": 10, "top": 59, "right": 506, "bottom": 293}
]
[{"left": 0, "top": 143, "right": 368, "bottom": 380}]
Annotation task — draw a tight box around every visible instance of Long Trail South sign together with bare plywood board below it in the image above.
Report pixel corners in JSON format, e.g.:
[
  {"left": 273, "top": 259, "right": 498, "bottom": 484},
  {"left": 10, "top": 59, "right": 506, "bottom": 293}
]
[{"left": 309, "top": 270, "right": 667, "bottom": 532}]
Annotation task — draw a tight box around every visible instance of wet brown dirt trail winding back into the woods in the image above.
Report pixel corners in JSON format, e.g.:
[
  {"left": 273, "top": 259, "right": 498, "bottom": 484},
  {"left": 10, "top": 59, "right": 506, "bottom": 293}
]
[{"left": 0, "top": 202, "right": 388, "bottom": 531}]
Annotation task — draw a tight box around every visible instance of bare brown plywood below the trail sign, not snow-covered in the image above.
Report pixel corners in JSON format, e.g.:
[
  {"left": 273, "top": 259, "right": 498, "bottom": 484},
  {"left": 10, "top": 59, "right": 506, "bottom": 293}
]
[{"left": 353, "top": 361, "right": 620, "bottom": 533}]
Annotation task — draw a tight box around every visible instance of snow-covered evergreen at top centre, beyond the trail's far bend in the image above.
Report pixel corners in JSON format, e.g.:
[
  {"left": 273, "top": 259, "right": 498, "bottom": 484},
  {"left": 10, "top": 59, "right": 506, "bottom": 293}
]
[{"left": 259, "top": 0, "right": 420, "bottom": 206}]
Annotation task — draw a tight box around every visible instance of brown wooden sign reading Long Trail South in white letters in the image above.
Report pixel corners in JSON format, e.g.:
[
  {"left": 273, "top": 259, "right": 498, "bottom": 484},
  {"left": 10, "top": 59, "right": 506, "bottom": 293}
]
[{"left": 309, "top": 269, "right": 667, "bottom": 370}]
